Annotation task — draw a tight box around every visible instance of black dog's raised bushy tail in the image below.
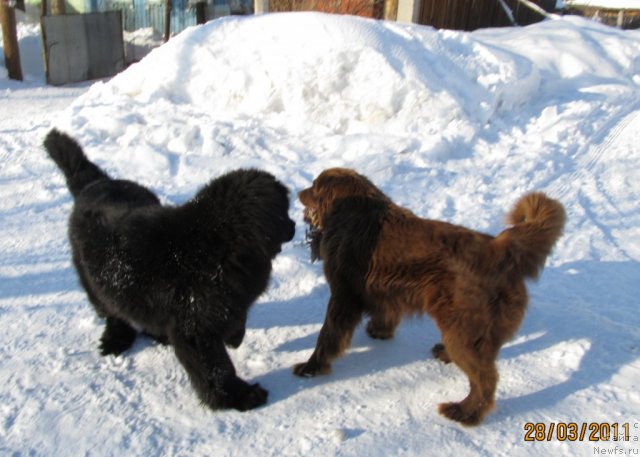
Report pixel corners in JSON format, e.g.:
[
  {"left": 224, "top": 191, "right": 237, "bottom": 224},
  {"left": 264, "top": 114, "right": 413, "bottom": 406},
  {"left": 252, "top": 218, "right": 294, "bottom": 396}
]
[{"left": 44, "top": 129, "right": 110, "bottom": 198}]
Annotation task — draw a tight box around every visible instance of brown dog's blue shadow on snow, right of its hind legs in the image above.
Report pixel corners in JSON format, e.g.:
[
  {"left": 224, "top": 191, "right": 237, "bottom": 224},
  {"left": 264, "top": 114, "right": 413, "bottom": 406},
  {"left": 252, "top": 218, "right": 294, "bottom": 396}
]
[{"left": 496, "top": 261, "right": 640, "bottom": 418}]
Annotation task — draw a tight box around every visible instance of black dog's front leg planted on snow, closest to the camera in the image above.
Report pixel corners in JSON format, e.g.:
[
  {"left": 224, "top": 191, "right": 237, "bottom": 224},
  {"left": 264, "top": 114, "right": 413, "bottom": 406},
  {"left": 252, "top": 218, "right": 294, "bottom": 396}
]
[{"left": 170, "top": 326, "right": 268, "bottom": 411}]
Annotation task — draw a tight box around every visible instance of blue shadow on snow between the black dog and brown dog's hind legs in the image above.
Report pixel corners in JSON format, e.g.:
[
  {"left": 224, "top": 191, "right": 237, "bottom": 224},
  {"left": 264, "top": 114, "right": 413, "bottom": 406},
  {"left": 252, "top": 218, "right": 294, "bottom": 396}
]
[{"left": 248, "top": 284, "right": 440, "bottom": 407}]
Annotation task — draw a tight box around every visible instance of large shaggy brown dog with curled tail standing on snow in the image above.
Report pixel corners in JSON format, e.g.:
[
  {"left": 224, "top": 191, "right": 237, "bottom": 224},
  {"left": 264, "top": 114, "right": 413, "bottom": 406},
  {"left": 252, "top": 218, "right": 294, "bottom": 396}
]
[{"left": 294, "top": 168, "right": 565, "bottom": 425}]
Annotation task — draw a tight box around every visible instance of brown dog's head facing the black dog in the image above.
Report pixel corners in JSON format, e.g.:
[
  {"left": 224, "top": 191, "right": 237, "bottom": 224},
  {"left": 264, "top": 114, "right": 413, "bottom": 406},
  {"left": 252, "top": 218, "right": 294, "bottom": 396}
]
[{"left": 298, "top": 168, "right": 388, "bottom": 231}]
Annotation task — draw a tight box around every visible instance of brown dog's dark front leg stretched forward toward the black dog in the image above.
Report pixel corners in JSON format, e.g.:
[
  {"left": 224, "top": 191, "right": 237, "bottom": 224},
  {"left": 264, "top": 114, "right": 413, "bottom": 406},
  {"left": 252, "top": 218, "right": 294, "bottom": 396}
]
[{"left": 293, "top": 295, "right": 362, "bottom": 378}]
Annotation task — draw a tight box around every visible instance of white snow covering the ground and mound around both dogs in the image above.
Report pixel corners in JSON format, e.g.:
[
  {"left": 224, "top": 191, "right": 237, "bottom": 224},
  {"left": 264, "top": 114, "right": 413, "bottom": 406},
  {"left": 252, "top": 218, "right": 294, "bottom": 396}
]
[{"left": 0, "top": 13, "right": 640, "bottom": 457}]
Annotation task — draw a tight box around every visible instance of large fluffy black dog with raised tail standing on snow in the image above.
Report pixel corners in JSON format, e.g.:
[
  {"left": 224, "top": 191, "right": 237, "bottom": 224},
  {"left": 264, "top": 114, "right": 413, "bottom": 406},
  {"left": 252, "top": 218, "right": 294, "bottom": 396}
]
[{"left": 44, "top": 130, "right": 295, "bottom": 411}]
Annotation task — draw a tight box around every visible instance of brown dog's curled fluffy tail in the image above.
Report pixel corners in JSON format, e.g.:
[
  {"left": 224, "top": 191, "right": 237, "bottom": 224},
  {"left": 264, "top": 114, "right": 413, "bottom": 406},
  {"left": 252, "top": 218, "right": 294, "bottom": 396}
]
[{"left": 493, "top": 192, "right": 566, "bottom": 278}]
